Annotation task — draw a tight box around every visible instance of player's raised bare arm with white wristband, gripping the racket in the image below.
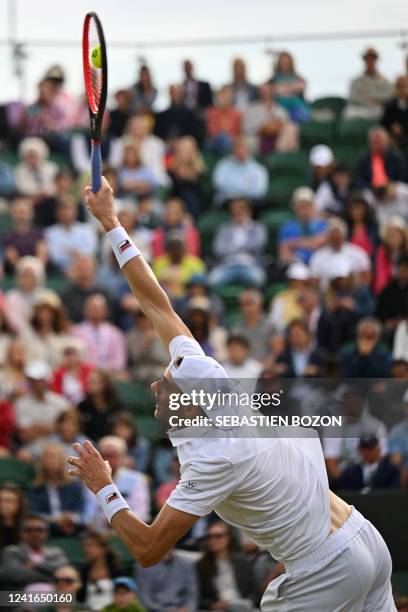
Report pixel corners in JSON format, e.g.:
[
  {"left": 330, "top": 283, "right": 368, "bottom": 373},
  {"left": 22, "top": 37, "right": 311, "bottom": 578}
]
[{"left": 85, "top": 178, "right": 191, "bottom": 347}]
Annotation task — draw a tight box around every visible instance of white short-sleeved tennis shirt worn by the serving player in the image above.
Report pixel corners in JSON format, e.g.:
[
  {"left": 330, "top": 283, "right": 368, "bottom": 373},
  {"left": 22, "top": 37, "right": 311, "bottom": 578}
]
[{"left": 167, "top": 336, "right": 330, "bottom": 562}]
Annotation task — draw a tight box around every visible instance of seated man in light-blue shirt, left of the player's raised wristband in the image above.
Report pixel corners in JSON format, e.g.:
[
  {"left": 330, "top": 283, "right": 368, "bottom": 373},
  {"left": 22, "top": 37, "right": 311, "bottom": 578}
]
[{"left": 45, "top": 196, "right": 97, "bottom": 272}]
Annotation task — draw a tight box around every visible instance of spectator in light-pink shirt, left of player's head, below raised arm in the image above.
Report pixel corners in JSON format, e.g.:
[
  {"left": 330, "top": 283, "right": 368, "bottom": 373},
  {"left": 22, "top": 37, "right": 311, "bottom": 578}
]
[{"left": 72, "top": 293, "right": 127, "bottom": 372}]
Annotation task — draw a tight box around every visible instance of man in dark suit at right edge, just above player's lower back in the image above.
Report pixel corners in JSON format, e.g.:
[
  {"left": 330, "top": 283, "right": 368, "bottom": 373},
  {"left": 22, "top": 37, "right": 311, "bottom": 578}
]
[{"left": 338, "top": 436, "right": 401, "bottom": 493}]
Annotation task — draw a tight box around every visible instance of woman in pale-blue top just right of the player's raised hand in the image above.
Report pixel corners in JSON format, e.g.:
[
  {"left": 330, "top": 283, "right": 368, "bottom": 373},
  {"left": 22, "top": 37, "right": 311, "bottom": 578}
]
[{"left": 118, "top": 138, "right": 160, "bottom": 198}]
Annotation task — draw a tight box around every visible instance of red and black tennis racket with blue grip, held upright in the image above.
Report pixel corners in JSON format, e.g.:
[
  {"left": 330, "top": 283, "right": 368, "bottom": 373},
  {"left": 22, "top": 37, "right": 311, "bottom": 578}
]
[{"left": 82, "top": 13, "right": 108, "bottom": 193}]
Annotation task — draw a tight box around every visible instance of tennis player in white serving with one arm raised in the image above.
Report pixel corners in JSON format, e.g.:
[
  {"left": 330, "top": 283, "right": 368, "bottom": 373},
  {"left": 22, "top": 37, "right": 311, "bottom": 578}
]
[{"left": 68, "top": 179, "right": 396, "bottom": 612}]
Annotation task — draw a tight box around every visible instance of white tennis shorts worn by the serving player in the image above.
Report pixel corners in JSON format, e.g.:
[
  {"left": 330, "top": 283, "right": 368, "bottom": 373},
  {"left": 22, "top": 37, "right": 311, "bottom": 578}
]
[{"left": 261, "top": 508, "right": 396, "bottom": 612}]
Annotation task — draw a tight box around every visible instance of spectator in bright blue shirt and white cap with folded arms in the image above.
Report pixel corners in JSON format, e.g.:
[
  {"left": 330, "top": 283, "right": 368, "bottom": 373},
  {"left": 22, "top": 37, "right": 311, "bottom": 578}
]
[{"left": 278, "top": 187, "right": 327, "bottom": 264}]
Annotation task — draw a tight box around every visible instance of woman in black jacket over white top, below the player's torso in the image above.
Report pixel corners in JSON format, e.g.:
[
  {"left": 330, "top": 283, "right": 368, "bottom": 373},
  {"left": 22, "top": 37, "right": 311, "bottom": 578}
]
[{"left": 197, "top": 520, "right": 258, "bottom": 612}]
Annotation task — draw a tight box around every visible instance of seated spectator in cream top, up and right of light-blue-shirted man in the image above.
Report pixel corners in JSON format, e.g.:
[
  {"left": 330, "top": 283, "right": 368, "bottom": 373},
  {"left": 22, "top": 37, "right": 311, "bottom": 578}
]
[{"left": 243, "top": 83, "right": 299, "bottom": 155}]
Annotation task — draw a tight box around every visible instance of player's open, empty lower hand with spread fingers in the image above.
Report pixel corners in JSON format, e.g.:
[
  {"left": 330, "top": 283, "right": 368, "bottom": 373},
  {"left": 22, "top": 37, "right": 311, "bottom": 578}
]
[{"left": 68, "top": 440, "right": 112, "bottom": 493}]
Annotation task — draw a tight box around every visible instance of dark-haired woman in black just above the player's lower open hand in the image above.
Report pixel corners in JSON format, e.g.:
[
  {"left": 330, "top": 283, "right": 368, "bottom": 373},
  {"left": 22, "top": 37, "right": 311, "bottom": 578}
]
[{"left": 78, "top": 369, "right": 122, "bottom": 441}]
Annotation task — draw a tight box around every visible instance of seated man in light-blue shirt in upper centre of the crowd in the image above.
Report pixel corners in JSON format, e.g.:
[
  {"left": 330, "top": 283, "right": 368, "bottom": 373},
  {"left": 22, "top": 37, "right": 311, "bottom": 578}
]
[{"left": 213, "top": 136, "right": 268, "bottom": 203}]
